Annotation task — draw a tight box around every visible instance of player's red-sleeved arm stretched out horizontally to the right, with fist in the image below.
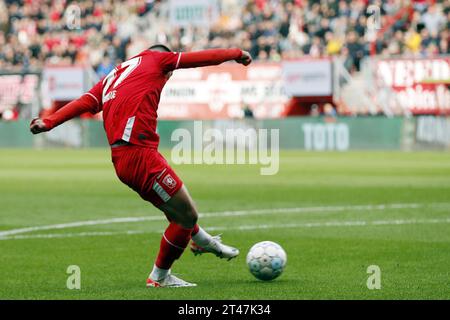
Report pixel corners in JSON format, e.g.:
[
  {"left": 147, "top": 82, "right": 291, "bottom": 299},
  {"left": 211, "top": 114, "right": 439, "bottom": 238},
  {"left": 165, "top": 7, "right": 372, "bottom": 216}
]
[{"left": 178, "top": 48, "right": 252, "bottom": 68}]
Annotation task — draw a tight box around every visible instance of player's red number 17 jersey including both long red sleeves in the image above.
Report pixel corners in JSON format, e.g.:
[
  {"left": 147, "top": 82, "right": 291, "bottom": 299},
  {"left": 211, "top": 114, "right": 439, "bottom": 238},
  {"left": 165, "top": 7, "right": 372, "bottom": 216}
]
[{"left": 43, "top": 48, "right": 244, "bottom": 148}]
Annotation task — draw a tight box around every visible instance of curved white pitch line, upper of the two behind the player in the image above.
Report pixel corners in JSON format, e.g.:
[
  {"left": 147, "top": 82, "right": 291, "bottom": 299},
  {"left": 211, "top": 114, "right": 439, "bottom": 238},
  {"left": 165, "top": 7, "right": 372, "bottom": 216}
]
[{"left": 0, "top": 203, "right": 421, "bottom": 237}]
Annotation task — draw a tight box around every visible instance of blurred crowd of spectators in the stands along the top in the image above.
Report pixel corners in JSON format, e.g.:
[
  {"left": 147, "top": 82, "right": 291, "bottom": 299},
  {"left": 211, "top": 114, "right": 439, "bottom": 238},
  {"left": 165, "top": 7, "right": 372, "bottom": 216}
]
[{"left": 0, "top": 0, "right": 450, "bottom": 76}]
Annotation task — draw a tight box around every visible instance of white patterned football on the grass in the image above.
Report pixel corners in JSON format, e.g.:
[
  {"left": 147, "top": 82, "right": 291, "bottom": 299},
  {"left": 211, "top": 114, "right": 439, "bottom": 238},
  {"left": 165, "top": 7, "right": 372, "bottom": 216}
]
[{"left": 247, "top": 241, "right": 287, "bottom": 281}]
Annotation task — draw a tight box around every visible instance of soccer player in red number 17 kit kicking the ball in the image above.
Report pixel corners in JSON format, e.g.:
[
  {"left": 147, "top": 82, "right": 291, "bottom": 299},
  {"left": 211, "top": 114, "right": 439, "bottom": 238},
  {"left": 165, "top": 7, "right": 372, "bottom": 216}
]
[{"left": 30, "top": 45, "right": 252, "bottom": 287}]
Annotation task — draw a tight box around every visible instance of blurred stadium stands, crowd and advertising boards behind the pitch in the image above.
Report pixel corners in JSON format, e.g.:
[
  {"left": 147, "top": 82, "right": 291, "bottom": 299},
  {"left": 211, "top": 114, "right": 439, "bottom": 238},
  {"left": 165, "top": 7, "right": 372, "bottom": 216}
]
[{"left": 0, "top": 0, "right": 450, "bottom": 150}]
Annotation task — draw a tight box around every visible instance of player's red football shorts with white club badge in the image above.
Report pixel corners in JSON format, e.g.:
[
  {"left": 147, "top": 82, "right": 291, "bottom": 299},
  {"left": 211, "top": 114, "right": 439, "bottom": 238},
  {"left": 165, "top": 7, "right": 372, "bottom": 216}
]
[{"left": 111, "top": 146, "right": 183, "bottom": 207}]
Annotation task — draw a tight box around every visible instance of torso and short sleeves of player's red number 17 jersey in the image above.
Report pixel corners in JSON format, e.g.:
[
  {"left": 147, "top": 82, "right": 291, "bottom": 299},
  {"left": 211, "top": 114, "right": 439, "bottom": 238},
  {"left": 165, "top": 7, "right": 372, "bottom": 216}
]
[{"left": 87, "top": 50, "right": 181, "bottom": 148}]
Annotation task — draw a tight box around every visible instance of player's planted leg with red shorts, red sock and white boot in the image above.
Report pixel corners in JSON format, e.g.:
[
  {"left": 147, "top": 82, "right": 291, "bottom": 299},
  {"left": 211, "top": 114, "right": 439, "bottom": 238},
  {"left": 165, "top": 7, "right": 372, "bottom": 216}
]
[{"left": 112, "top": 146, "right": 197, "bottom": 287}]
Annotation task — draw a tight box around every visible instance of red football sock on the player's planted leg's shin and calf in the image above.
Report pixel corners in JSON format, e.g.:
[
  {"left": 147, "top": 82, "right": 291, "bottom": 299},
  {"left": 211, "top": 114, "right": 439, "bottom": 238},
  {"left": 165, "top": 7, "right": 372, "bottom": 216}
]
[{"left": 155, "top": 222, "right": 193, "bottom": 270}]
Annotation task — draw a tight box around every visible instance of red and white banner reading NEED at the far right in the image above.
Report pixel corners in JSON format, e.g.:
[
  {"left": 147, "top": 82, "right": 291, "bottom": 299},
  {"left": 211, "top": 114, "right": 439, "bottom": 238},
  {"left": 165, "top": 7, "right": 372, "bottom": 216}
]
[{"left": 376, "top": 57, "right": 450, "bottom": 114}]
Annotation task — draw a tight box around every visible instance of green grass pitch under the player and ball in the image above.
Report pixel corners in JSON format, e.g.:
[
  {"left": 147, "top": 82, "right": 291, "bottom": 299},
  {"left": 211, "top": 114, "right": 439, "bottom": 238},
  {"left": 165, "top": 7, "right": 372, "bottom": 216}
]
[{"left": 0, "top": 149, "right": 450, "bottom": 299}]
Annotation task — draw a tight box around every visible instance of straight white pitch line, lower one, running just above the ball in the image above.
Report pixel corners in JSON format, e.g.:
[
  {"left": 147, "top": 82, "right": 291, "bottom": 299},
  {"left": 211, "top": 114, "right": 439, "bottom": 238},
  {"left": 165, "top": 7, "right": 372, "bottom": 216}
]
[{"left": 0, "top": 217, "right": 450, "bottom": 241}]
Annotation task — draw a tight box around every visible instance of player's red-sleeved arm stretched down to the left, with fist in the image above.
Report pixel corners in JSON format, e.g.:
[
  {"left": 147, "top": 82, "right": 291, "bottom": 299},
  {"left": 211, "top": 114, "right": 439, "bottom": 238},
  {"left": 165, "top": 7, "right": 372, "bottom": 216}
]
[{"left": 30, "top": 94, "right": 99, "bottom": 134}]
